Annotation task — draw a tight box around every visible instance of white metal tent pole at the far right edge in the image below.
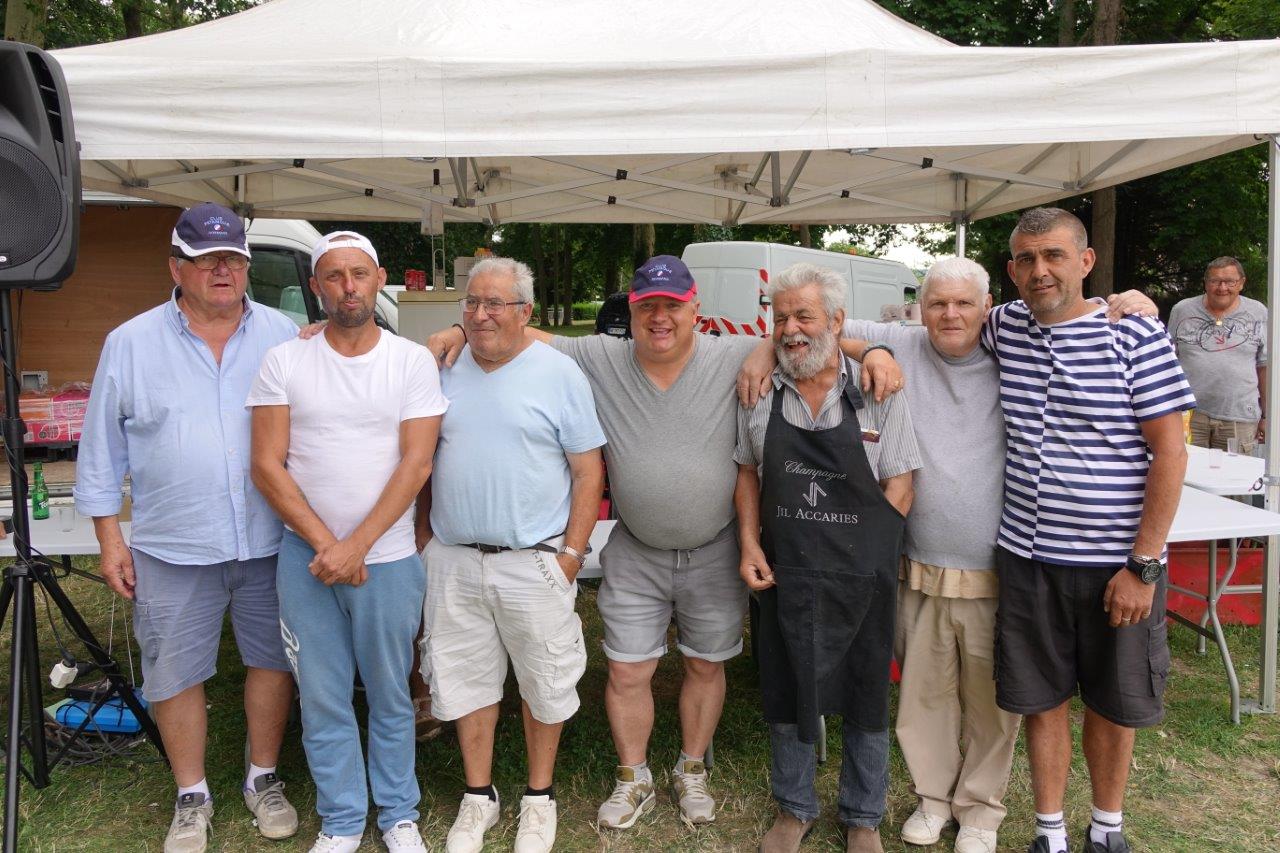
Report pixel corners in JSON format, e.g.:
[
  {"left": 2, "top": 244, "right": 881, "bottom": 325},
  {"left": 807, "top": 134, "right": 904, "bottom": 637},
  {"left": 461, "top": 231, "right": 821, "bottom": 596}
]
[{"left": 1257, "top": 134, "right": 1280, "bottom": 713}]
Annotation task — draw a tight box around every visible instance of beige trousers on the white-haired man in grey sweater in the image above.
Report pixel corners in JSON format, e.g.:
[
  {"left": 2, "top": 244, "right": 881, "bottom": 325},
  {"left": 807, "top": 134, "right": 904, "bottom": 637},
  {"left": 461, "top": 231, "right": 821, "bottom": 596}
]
[{"left": 896, "top": 583, "right": 1021, "bottom": 830}]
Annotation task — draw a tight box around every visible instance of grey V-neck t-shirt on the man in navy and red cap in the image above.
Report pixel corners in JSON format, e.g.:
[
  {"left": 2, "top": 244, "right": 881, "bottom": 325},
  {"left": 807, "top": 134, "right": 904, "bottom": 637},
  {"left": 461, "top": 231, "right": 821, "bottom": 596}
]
[{"left": 552, "top": 334, "right": 760, "bottom": 549}]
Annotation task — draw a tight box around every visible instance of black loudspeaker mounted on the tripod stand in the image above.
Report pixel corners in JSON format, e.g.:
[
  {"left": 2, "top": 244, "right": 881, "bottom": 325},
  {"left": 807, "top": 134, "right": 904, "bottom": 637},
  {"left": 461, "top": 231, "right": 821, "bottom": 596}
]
[{"left": 0, "top": 41, "right": 81, "bottom": 289}]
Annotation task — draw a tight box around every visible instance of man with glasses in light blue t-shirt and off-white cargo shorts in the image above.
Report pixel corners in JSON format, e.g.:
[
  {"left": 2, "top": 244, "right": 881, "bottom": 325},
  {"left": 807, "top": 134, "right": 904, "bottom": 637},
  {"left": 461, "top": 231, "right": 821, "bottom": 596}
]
[{"left": 419, "top": 257, "right": 604, "bottom": 853}]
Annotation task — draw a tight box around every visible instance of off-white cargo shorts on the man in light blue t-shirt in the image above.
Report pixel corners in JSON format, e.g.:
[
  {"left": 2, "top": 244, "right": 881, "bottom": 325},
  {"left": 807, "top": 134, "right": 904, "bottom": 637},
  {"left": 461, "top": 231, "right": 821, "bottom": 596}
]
[{"left": 420, "top": 538, "right": 586, "bottom": 724}]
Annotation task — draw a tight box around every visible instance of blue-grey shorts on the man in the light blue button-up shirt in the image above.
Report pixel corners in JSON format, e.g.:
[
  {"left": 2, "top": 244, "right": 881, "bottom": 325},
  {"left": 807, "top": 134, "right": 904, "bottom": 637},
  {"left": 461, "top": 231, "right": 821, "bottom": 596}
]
[{"left": 133, "top": 549, "right": 289, "bottom": 702}]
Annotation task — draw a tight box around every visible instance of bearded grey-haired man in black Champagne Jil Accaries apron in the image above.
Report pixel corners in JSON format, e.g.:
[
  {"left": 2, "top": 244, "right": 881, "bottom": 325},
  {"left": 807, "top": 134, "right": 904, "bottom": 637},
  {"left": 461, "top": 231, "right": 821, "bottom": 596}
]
[{"left": 733, "top": 264, "right": 920, "bottom": 853}]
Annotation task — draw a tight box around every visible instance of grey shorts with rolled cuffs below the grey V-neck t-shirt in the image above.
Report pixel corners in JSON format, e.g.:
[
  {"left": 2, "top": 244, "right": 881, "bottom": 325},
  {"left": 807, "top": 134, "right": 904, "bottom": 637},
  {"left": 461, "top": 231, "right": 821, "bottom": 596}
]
[{"left": 596, "top": 521, "right": 748, "bottom": 663}]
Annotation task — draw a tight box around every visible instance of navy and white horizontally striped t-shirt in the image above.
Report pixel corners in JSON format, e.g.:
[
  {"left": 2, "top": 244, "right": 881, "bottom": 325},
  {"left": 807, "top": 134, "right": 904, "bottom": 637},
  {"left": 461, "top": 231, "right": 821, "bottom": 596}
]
[{"left": 983, "top": 301, "right": 1196, "bottom": 567}]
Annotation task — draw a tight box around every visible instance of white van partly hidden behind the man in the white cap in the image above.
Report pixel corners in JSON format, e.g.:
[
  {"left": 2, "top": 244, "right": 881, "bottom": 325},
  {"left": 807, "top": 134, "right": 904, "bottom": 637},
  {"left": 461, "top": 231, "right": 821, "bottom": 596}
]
[{"left": 246, "top": 219, "right": 404, "bottom": 332}]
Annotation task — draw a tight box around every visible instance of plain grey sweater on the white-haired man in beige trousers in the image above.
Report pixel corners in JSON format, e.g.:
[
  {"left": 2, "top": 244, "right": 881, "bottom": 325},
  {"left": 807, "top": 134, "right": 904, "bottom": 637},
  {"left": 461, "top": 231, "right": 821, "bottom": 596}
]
[{"left": 842, "top": 320, "right": 1005, "bottom": 569}]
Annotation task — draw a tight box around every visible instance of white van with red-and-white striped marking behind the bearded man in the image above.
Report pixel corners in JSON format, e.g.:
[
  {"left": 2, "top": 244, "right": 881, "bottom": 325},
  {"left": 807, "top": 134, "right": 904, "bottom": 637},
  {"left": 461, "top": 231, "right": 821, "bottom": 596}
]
[{"left": 681, "top": 242, "right": 916, "bottom": 336}]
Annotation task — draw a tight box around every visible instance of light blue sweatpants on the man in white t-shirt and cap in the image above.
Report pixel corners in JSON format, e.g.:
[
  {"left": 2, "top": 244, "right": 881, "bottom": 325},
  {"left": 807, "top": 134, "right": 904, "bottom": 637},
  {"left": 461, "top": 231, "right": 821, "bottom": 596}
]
[{"left": 275, "top": 530, "right": 426, "bottom": 835}]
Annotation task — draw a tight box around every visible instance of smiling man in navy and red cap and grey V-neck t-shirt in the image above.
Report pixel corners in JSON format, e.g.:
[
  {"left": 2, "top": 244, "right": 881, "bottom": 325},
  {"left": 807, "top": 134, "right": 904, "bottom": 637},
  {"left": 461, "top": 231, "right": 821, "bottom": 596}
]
[{"left": 428, "top": 255, "right": 901, "bottom": 829}]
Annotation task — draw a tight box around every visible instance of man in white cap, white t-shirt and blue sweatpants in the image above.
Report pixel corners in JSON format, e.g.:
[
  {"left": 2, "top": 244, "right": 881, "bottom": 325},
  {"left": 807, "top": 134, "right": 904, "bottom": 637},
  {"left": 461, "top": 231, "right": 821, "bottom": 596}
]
[{"left": 244, "top": 231, "right": 448, "bottom": 853}]
